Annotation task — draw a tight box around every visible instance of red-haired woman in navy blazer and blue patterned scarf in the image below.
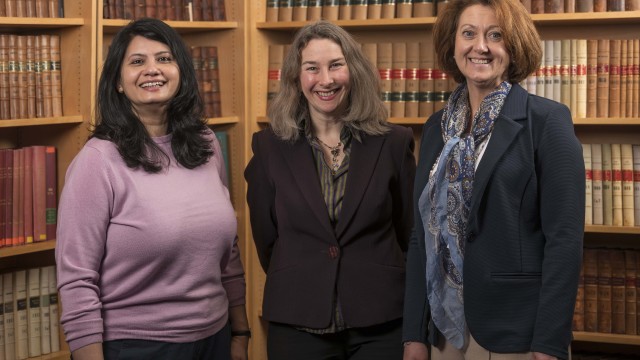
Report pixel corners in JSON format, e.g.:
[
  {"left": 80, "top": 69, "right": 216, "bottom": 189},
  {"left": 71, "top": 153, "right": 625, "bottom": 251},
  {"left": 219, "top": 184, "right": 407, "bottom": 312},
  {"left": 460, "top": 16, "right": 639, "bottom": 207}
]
[{"left": 403, "top": 0, "right": 585, "bottom": 360}]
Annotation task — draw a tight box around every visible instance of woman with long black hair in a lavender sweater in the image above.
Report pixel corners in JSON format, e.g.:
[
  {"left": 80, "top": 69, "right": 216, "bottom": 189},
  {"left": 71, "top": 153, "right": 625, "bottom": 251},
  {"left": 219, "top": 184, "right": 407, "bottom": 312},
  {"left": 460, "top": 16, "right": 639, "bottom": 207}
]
[{"left": 56, "top": 19, "right": 250, "bottom": 360}]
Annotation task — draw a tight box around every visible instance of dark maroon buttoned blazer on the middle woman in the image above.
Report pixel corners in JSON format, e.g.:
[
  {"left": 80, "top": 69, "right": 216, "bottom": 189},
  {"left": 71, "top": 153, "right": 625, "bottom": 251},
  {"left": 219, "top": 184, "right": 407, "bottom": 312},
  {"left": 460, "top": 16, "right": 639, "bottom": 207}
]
[{"left": 244, "top": 125, "right": 416, "bottom": 328}]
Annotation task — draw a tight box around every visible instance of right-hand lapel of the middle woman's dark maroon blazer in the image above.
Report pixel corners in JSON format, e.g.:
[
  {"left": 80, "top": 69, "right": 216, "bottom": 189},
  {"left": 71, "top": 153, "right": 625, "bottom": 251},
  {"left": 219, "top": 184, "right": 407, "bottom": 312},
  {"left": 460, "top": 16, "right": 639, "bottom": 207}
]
[{"left": 336, "top": 135, "right": 385, "bottom": 238}]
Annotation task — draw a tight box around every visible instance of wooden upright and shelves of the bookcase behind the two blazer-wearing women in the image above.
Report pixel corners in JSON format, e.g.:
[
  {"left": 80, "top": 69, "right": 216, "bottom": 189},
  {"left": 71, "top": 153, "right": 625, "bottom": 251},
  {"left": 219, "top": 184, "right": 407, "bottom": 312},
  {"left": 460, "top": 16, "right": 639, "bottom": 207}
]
[{"left": 245, "top": 4, "right": 640, "bottom": 360}]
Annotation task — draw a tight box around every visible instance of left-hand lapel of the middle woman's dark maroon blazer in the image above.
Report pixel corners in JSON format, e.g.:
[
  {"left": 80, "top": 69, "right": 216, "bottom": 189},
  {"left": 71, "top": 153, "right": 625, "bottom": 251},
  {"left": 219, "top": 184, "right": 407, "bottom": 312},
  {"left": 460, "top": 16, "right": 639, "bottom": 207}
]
[{"left": 280, "top": 137, "right": 333, "bottom": 235}]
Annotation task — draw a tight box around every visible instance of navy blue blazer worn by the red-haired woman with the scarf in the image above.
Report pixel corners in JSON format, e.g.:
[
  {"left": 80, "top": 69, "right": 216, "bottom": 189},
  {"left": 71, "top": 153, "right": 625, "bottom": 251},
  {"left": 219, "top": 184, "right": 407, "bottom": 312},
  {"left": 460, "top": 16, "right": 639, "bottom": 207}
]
[{"left": 403, "top": 84, "right": 585, "bottom": 358}]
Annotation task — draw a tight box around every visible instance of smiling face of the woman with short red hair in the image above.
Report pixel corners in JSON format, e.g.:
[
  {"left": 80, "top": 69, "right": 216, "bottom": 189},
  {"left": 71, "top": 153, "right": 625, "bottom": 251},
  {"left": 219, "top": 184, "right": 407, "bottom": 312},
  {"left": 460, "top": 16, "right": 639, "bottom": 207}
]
[{"left": 454, "top": 5, "right": 510, "bottom": 93}]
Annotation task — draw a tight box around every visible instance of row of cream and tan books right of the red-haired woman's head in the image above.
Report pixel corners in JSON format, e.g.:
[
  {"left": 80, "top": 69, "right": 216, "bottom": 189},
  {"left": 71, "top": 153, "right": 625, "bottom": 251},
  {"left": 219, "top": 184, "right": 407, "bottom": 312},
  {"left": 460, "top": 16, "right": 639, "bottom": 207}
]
[{"left": 522, "top": 38, "right": 640, "bottom": 118}]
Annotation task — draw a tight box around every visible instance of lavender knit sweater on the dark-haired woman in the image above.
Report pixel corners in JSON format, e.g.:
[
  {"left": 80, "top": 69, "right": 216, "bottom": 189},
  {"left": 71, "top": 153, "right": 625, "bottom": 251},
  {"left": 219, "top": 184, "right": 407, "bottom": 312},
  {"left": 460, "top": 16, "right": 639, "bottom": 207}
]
[{"left": 56, "top": 134, "right": 245, "bottom": 351}]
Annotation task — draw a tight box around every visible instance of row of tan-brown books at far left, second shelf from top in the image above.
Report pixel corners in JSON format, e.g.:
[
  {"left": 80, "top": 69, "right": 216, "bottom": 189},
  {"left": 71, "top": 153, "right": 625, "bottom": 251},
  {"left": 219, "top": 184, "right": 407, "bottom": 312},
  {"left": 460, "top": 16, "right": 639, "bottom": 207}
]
[{"left": 0, "top": 34, "right": 63, "bottom": 120}]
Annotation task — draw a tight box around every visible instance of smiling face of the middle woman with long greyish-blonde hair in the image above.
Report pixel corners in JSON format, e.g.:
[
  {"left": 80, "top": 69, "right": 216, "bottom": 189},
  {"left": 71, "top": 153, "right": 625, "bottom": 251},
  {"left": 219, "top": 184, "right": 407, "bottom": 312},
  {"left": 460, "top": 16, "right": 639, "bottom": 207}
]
[{"left": 300, "top": 39, "right": 349, "bottom": 121}]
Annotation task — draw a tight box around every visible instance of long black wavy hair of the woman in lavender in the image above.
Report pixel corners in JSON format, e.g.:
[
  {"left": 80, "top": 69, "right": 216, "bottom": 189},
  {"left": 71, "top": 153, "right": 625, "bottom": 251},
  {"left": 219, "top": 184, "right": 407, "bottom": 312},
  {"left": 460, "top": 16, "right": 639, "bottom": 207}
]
[{"left": 90, "top": 18, "right": 213, "bottom": 173}]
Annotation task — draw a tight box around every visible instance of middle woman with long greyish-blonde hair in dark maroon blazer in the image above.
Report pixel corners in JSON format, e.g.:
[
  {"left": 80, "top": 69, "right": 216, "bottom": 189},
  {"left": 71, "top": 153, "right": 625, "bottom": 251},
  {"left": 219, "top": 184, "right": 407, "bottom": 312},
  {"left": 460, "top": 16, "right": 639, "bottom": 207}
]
[{"left": 245, "top": 21, "right": 416, "bottom": 360}]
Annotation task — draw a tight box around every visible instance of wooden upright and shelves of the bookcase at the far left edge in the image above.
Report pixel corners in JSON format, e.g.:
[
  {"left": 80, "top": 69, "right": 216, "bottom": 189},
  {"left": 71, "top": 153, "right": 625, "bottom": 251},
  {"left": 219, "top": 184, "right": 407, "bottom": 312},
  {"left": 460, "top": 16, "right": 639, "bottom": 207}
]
[{"left": 0, "top": 0, "right": 97, "bottom": 360}]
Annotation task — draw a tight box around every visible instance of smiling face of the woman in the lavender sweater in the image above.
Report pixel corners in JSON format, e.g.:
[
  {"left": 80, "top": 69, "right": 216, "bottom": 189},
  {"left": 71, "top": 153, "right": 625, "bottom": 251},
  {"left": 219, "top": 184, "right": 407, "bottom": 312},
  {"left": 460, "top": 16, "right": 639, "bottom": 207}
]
[{"left": 118, "top": 36, "right": 180, "bottom": 114}]
